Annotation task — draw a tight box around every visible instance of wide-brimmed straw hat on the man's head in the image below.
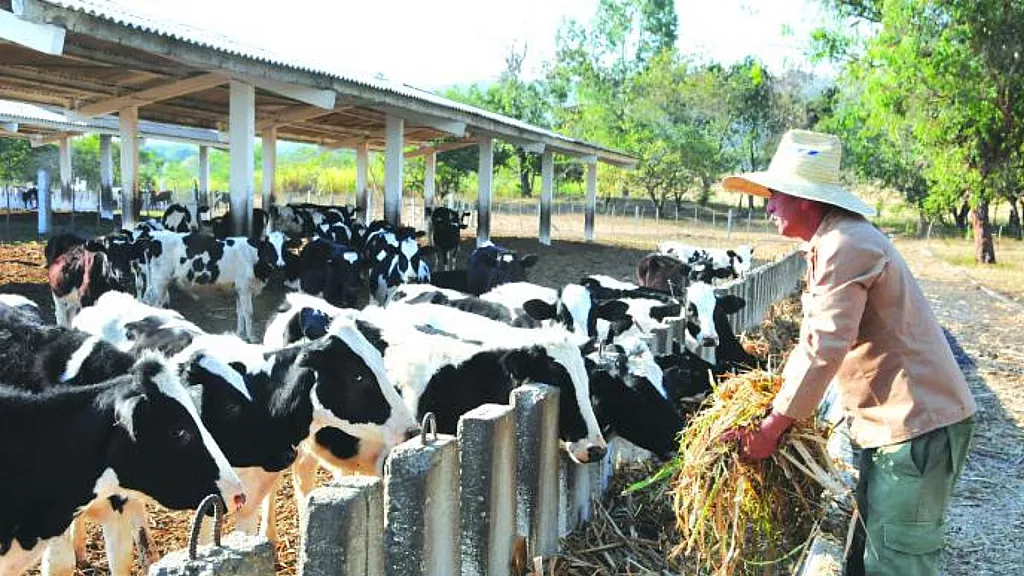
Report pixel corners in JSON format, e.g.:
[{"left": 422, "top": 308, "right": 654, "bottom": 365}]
[{"left": 722, "top": 130, "right": 874, "bottom": 216}]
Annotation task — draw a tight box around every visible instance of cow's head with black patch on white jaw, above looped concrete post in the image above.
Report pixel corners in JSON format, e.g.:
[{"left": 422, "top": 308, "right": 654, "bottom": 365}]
[{"left": 295, "top": 318, "right": 418, "bottom": 475}]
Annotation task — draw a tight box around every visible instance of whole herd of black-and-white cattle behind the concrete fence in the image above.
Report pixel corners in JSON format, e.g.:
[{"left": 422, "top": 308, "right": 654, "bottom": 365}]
[{"left": 0, "top": 205, "right": 759, "bottom": 576}]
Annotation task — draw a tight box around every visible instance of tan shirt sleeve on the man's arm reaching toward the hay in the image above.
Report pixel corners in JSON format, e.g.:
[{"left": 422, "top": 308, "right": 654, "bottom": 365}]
[{"left": 773, "top": 226, "right": 889, "bottom": 418}]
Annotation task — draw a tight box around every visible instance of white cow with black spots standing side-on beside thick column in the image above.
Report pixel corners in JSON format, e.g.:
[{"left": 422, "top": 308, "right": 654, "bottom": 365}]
[{"left": 136, "top": 227, "right": 286, "bottom": 340}]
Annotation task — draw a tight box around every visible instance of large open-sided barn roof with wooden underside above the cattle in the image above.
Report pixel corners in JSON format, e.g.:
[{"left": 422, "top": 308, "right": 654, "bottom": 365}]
[{"left": 0, "top": 0, "right": 636, "bottom": 167}]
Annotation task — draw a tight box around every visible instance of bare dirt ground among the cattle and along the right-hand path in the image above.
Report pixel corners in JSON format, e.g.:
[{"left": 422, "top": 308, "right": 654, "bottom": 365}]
[{"left": 0, "top": 213, "right": 1024, "bottom": 576}]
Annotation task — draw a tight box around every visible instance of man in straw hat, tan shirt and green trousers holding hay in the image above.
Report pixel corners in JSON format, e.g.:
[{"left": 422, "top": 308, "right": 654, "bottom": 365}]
[{"left": 722, "top": 130, "right": 976, "bottom": 576}]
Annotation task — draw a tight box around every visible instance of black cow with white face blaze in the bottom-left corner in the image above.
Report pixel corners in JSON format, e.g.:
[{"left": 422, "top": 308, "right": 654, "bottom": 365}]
[{"left": 0, "top": 350, "right": 245, "bottom": 575}]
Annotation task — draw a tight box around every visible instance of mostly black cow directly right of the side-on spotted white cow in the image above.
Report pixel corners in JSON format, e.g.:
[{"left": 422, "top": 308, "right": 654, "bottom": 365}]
[{"left": 290, "top": 238, "right": 366, "bottom": 307}]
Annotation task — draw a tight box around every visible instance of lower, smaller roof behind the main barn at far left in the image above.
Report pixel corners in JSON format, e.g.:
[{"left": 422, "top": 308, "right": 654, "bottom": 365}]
[{"left": 0, "top": 99, "right": 227, "bottom": 148}]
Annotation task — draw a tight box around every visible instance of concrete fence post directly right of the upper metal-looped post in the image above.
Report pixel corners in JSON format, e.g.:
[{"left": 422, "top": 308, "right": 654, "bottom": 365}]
[{"left": 459, "top": 404, "right": 516, "bottom": 576}]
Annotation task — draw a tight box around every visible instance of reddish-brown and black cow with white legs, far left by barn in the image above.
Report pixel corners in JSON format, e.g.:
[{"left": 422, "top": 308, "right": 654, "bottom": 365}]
[{"left": 46, "top": 236, "right": 124, "bottom": 326}]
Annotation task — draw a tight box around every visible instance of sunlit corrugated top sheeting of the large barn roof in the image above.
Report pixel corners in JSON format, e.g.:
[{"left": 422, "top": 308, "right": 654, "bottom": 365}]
[{"left": 29, "top": 0, "right": 629, "bottom": 163}]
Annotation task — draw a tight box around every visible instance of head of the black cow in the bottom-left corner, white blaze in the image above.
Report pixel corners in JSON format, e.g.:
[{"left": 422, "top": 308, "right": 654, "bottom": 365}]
[{"left": 106, "top": 354, "right": 245, "bottom": 509}]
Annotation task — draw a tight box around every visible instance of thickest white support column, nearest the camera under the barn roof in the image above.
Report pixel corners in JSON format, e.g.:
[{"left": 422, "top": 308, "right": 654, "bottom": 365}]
[{"left": 228, "top": 80, "right": 256, "bottom": 236}]
